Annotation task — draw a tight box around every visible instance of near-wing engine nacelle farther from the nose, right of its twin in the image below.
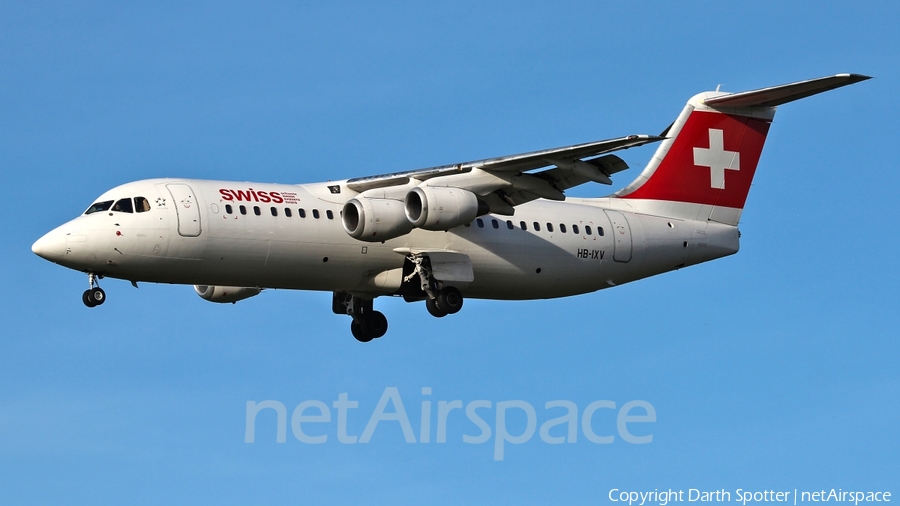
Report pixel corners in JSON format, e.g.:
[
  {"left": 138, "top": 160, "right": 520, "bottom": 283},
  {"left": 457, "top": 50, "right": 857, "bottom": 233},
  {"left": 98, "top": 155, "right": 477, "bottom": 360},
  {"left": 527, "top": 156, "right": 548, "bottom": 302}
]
[{"left": 404, "top": 186, "right": 489, "bottom": 230}]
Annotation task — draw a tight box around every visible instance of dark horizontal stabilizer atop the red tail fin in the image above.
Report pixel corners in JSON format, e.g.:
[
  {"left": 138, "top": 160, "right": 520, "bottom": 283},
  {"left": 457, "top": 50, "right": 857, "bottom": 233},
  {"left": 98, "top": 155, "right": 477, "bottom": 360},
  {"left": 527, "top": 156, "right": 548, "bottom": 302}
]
[{"left": 704, "top": 74, "right": 871, "bottom": 108}]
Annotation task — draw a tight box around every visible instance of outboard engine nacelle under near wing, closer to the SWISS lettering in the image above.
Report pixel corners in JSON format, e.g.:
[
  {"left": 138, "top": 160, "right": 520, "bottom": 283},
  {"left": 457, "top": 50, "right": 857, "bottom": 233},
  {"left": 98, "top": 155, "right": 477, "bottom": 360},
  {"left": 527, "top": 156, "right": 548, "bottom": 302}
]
[{"left": 341, "top": 197, "right": 413, "bottom": 242}]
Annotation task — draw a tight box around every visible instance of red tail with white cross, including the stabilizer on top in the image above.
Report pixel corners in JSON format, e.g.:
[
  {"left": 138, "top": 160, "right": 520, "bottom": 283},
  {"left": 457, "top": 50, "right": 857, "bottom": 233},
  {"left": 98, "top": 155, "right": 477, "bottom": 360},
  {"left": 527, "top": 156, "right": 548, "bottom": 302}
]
[{"left": 616, "top": 74, "right": 869, "bottom": 225}]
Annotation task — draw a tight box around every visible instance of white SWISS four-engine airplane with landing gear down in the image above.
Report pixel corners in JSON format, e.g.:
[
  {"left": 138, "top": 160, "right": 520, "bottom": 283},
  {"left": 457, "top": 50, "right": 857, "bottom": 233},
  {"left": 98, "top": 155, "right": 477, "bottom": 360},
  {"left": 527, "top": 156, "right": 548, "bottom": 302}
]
[{"left": 32, "top": 74, "right": 870, "bottom": 342}]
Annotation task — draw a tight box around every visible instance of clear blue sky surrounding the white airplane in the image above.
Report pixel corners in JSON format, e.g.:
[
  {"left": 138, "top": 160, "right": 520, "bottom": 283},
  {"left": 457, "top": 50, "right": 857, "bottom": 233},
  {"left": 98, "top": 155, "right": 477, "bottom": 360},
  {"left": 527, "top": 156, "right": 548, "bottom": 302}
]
[{"left": 0, "top": 2, "right": 900, "bottom": 504}]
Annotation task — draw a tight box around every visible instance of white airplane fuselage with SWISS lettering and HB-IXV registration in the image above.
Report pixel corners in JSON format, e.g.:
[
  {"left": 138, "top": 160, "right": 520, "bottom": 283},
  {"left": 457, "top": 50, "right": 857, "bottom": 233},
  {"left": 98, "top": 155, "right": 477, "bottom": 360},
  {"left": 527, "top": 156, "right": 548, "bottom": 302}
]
[{"left": 35, "top": 179, "right": 739, "bottom": 300}]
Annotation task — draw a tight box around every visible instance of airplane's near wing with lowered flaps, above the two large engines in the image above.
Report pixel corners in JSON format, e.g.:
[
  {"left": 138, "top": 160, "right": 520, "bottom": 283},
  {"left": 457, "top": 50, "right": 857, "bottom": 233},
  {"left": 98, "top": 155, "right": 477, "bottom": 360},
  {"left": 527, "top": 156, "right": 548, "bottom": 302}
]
[{"left": 346, "top": 135, "right": 663, "bottom": 214}]
